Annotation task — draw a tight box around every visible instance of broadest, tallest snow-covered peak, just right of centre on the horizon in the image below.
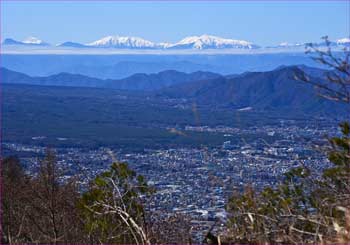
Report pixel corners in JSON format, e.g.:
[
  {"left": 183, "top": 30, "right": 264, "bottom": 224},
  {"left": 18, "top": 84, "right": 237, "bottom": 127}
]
[{"left": 168, "top": 34, "right": 258, "bottom": 49}]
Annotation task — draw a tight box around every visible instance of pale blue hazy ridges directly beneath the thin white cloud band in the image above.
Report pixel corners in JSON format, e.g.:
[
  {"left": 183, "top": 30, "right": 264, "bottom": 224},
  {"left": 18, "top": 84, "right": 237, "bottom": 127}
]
[{"left": 1, "top": 53, "right": 321, "bottom": 79}]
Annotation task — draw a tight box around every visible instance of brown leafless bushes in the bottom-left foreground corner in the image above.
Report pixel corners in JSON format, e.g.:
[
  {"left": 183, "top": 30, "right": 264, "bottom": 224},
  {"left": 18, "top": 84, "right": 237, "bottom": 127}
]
[{"left": 2, "top": 151, "right": 84, "bottom": 244}]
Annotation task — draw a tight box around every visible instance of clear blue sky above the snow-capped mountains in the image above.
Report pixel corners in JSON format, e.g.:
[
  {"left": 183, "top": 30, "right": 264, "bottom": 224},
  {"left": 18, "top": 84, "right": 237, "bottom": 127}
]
[{"left": 1, "top": 0, "right": 350, "bottom": 45}]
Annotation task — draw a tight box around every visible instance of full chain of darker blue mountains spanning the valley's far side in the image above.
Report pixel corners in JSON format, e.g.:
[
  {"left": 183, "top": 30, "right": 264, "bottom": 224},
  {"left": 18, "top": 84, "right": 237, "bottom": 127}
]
[{"left": 0, "top": 66, "right": 346, "bottom": 115}]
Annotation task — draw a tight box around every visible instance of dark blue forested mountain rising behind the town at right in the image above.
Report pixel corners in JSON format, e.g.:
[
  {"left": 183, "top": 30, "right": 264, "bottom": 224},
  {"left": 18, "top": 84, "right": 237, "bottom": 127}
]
[{"left": 157, "top": 66, "right": 346, "bottom": 115}]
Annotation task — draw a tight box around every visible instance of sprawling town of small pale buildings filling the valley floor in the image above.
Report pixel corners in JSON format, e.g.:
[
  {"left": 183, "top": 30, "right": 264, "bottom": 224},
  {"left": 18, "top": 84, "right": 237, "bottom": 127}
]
[{"left": 2, "top": 118, "right": 337, "bottom": 239}]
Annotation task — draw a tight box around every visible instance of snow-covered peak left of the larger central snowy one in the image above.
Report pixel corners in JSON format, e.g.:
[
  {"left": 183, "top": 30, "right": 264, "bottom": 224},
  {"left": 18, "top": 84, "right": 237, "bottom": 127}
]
[{"left": 86, "top": 36, "right": 157, "bottom": 48}]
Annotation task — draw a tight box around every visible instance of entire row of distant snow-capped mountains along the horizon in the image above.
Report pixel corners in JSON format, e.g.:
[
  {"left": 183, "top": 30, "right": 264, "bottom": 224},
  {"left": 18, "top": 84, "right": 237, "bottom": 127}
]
[{"left": 2, "top": 35, "right": 350, "bottom": 50}]
